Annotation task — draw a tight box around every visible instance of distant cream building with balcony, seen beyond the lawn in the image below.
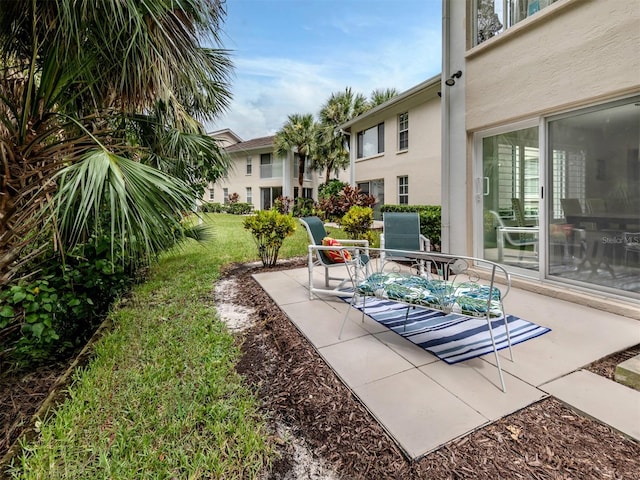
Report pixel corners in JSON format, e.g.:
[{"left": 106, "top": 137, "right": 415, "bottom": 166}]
[{"left": 208, "top": 129, "right": 319, "bottom": 210}]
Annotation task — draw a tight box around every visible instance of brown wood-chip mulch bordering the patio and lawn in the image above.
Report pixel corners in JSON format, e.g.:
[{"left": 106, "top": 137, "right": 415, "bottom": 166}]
[{"left": 0, "top": 259, "right": 640, "bottom": 480}]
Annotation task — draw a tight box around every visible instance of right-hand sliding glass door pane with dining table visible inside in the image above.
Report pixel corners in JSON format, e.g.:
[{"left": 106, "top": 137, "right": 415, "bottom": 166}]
[{"left": 547, "top": 97, "right": 640, "bottom": 297}]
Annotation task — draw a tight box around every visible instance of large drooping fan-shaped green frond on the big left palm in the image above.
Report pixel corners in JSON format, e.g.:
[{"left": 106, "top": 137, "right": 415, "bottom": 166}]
[{"left": 54, "top": 150, "right": 196, "bottom": 257}]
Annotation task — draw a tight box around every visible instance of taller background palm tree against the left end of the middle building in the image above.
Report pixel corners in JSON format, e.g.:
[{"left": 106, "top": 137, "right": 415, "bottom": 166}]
[{"left": 314, "top": 87, "right": 369, "bottom": 184}]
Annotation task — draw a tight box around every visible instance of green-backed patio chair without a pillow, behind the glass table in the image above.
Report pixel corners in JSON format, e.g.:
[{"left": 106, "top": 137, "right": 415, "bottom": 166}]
[{"left": 380, "top": 212, "right": 431, "bottom": 275}]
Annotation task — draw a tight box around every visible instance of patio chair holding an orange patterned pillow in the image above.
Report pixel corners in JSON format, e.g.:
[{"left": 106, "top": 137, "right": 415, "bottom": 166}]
[{"left": 299, "top": 217, "right": 369, "bottom": 299}]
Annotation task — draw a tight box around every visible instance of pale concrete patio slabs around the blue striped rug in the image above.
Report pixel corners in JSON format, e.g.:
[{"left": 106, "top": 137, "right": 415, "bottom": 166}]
[{"left": 254, "top": 268, "right": 640, "bottom": 459}]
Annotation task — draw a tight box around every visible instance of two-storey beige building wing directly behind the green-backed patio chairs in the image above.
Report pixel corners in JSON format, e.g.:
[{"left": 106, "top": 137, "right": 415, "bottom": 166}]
[{"left": 342, "top": 75, "right": 441, "bottom": 218}]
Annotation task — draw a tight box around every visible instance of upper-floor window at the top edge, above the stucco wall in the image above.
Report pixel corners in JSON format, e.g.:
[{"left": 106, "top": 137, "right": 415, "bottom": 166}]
[{"left": 475, "top": 0, "right": 556, "bottom": 45}]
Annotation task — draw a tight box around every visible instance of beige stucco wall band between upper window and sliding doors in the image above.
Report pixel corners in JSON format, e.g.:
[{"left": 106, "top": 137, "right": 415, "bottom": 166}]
[{"left": 465, "top": 0, "right": 640, "bottom": 131}]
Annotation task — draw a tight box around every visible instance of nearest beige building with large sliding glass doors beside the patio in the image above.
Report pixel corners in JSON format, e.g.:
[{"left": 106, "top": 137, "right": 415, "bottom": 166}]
[{"left": 441, "top": 0, "right": 640, "bottom": 301}]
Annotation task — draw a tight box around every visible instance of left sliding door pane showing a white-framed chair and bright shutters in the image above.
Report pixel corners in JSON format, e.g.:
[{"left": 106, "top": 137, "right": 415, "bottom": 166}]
[{"left": 482, "top": 127, "right": 540, "bottom": 271}]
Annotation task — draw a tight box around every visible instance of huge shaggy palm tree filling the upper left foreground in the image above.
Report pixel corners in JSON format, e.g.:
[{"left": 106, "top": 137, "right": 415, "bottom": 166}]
[{"left": 0, "top": 0, "right": 231, "bottom": 285}]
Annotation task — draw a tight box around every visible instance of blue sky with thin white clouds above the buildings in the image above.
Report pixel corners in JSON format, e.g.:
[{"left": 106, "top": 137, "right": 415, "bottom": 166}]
[{"left": 205, "top": 0, "right": 442, "bottom": 140}]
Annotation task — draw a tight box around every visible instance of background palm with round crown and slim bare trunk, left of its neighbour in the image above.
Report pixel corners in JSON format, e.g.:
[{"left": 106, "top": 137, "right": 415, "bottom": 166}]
[{"left": 273, "top": 113, "right": 317, "bottom": 196}]
